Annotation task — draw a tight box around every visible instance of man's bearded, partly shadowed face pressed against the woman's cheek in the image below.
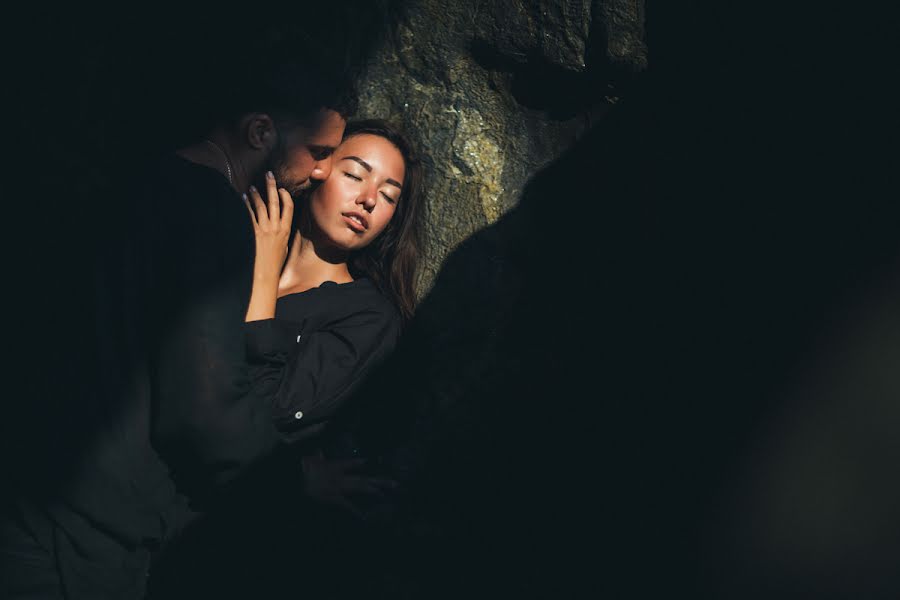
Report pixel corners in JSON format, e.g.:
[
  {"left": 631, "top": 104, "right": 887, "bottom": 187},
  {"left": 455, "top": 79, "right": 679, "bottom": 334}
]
[{"left": 269, "top": 109, "right": 346, "bottom": 197}]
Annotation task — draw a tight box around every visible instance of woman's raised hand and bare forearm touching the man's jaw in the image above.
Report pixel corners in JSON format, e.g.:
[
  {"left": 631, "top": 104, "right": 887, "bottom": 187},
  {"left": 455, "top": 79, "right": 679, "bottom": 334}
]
[{"left": 244, "top": 171, "right": 294, "bottom": 321}]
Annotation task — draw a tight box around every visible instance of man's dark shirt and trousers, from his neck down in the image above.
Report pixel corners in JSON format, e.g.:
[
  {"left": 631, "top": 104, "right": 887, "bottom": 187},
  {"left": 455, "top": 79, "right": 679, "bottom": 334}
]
[{"left": 0, "top": 156, "right": 292, "bottom": 598}]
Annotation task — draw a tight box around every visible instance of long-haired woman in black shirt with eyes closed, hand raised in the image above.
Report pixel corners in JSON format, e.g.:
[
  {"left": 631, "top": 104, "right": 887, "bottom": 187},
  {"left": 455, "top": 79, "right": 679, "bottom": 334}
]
[{"left": 244, "top": 120, "right": 422, "bottom": 441}]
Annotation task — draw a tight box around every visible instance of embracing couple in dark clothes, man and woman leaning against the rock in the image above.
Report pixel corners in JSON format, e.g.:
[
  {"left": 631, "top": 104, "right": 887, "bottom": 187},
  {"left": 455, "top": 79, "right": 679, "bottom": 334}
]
[{"left": 0, "top": 27, "right": 422, "bottom": 598}]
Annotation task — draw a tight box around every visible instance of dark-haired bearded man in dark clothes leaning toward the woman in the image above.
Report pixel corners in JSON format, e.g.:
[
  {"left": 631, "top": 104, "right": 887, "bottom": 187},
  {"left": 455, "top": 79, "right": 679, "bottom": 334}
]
[{"left": 0, "top": 41, "right": 354, "bottom": 598}]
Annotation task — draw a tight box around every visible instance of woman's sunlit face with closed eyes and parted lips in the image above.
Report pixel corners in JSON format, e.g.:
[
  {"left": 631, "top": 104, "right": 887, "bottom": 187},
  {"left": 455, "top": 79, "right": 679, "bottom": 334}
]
[{"left": 309, "top": 133, "right": 406, "bottom": 251}]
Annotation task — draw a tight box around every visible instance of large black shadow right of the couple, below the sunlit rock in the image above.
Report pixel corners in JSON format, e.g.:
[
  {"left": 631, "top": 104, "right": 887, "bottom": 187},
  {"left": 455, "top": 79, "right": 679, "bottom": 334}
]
[{"left": 7, "top": 2, "right": 900, "bottom": 598}]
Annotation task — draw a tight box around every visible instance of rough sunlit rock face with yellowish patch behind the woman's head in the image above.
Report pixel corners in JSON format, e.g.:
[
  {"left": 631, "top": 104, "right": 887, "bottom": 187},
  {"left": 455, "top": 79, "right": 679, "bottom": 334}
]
[{"left": 360, "top": 0, "right": 647, "bottom": 293}]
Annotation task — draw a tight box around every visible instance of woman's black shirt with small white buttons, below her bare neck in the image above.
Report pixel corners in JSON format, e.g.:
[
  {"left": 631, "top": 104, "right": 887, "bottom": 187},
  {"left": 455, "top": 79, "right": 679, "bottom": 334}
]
[{"left": 248, "top": 308, "right": 399, "bottom": 440}]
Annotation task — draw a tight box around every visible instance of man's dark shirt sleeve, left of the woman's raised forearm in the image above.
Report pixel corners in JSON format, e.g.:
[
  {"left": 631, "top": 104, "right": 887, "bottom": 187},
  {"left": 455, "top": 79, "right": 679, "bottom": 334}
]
[{"left": 141, "top": 176, "right": 290, "bottom": 502}]
